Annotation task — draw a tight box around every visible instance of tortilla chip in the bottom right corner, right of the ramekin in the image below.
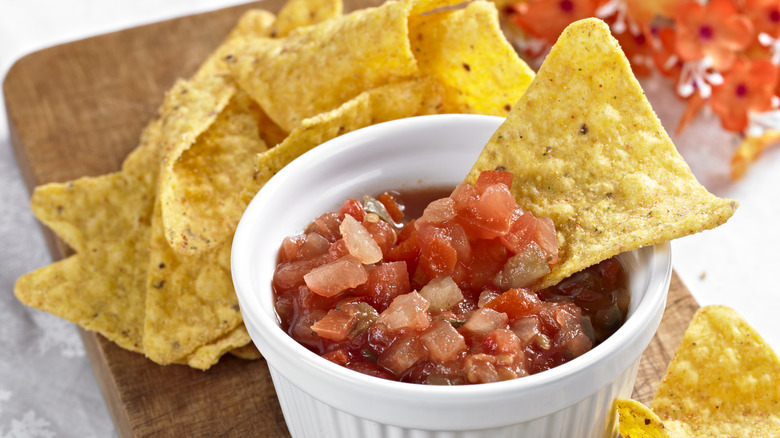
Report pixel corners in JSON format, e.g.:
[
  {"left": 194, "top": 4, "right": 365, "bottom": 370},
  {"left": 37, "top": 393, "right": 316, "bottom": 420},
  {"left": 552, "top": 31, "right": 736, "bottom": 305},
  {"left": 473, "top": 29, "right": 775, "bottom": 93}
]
[{"left": 650, "top": 306, "right": 780, "bottom": 438}]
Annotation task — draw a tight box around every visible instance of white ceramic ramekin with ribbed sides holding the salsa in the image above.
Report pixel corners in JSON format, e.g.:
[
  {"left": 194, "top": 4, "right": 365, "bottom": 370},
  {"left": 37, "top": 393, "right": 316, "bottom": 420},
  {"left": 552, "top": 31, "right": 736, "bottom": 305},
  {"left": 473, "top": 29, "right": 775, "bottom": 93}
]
[{"left": 231, "top": 115, "right": 671, "bottom": 438}]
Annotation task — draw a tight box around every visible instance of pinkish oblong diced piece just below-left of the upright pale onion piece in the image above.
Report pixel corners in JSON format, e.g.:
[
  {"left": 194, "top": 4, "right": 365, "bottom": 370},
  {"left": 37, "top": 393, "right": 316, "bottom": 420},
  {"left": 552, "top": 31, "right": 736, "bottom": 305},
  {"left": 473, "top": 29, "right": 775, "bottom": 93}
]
[{"left": 303, "top": 255, "right": 368, "bottom": 297}]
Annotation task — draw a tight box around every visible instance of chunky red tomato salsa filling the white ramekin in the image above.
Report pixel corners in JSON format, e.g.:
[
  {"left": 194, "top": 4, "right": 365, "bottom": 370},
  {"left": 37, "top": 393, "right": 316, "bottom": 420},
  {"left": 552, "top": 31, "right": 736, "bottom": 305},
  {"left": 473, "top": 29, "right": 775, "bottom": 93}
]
[{"left": 273, "top": 171, "right": 629, "bottom": 385}]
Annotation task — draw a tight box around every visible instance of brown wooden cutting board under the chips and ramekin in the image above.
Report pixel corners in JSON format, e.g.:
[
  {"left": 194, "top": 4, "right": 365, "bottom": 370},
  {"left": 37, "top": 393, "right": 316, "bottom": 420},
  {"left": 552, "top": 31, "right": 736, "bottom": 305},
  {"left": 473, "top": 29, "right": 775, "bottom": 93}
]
[{"left": 3, "top": 0, "right": 698, "bottom": 437}]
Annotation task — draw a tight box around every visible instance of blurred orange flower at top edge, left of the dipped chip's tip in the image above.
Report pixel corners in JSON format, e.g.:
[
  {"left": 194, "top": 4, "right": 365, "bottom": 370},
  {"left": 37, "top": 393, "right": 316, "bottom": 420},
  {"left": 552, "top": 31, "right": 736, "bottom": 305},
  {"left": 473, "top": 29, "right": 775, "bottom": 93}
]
[{"left": 509, "top": 0, "right": 598, "bottom": 44}]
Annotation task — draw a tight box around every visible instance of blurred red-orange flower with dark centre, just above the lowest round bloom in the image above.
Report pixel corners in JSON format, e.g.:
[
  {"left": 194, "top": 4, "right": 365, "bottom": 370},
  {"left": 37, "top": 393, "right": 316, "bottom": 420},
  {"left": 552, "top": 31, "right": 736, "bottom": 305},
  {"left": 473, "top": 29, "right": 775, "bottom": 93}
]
[{"left": 674, "top": 0, "right": 753, "bottom": 70}]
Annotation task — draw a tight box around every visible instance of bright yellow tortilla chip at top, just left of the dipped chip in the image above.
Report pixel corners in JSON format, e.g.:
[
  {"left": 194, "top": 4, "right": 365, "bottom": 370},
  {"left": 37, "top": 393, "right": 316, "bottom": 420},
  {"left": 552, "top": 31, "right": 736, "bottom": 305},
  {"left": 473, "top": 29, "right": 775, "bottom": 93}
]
[{"left": 409, "top": 1, "right": 534, "bottom": 117}]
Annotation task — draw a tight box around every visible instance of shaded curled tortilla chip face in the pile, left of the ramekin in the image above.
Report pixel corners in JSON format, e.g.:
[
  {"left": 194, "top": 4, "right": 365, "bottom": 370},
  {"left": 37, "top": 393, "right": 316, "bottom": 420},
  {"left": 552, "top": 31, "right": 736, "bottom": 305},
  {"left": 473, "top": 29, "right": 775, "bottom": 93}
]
[{"left": 159, "top": 90, "right": 267, "bottom": 253}]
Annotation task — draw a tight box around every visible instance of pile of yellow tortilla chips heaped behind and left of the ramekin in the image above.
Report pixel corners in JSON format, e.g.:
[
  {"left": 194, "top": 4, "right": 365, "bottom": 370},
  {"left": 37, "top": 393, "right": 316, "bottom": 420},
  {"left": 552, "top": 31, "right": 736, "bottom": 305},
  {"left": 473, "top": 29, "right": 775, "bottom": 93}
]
[{"left": 15, "top": 0, "right": 534, "bottom": 369}]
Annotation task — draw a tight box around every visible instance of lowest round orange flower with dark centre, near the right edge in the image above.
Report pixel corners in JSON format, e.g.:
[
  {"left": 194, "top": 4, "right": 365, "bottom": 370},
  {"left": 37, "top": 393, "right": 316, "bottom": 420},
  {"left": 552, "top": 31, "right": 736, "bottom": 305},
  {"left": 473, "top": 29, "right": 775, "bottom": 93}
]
[{"left": 710, "top": 59, "right": 778, "bottom": 132}]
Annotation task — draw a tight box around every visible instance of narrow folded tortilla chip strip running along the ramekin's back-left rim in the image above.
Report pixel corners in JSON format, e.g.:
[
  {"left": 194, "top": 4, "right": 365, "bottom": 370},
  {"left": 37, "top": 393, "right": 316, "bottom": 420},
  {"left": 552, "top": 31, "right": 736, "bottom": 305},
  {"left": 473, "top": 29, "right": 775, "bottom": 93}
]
[{"left": 243, "top": 78, "right": 443, "bottom": 202}]
